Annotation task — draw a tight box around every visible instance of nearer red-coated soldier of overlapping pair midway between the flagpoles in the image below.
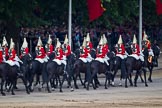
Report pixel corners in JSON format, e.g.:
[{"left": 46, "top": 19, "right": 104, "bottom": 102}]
[{"left": 95, "top": 36, "right": 109, "bottom": 66}]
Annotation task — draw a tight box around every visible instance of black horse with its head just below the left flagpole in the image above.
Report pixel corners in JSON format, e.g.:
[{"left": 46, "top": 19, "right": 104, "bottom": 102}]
[{"left": 46, "top": 53, "right": 75, "bottom": 92}]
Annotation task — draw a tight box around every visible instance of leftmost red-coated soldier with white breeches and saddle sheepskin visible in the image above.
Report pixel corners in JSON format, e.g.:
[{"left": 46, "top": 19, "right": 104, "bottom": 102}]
[{"left": 6, "top": 38, "right": 21, "bottom": 67}]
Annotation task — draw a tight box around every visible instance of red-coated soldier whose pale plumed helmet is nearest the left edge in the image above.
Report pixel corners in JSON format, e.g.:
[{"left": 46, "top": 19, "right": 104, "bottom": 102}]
[{"left": 2, "top": 36, "right": 9, "bottom": 61}]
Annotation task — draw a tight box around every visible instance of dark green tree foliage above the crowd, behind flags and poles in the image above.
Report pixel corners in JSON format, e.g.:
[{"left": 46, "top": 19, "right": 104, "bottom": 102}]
[{"left": 0, "top": 0, "right": 162, "bottom": 36}]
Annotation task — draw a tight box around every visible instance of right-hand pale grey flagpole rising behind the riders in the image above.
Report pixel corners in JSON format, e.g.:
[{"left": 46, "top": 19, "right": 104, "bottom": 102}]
[{"left": 139, "top": 0, "right": 142, "bottom": 51}]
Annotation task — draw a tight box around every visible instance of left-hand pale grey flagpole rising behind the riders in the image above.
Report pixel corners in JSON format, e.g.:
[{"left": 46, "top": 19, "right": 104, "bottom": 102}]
[{"left": 68, "top": 0, "right": 72, "bottom": 48}]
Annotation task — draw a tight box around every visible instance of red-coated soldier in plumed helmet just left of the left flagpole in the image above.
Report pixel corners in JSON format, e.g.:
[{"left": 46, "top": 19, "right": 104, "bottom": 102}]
[{"left": 62, "top": 35, "right": 71, "bottom": 60}]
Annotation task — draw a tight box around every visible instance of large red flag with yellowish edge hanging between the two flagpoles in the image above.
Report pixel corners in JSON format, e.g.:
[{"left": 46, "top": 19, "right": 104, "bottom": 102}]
[{"left": 87, "top": 0, "right": 105, "bottom": 21}]
